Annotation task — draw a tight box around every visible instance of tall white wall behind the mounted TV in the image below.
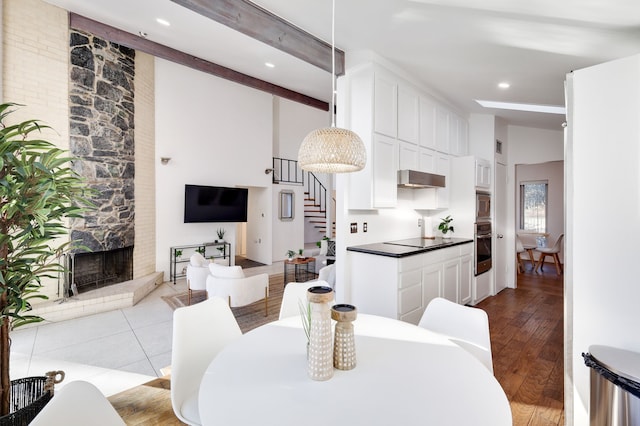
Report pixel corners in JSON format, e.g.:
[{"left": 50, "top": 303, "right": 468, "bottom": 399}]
[{"left": 155, "top": 58, "right": 272, "bottom": 279}]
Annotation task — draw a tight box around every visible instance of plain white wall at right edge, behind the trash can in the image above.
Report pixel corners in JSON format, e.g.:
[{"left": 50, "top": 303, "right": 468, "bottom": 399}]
[{"left": 565, "top": 56, "right": 640, "bottom": 425}]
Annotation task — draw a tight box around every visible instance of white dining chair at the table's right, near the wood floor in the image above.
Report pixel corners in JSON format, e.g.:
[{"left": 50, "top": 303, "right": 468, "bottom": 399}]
[{"left": 418, "top": 297, "right": 493, "bottom": 374}]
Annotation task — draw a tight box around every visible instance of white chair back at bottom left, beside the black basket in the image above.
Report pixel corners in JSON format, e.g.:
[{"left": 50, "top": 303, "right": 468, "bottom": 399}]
[{"left": 29, "top": 380, "right": 125, "bottom": 426}]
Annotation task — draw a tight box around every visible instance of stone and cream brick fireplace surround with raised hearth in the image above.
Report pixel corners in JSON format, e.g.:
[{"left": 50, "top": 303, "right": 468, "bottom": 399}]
[{"left": 2, "top": 0, "right": 164, "bottom": 322}]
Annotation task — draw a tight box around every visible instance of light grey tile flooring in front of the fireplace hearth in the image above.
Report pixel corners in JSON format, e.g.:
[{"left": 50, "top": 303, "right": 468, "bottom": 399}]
[{"left": 11, "top": 262, "right": 283, "bottom": 396}]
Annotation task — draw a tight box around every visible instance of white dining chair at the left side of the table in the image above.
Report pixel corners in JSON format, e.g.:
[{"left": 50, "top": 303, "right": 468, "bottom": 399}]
[{"left": 171, "top": 297, "right": 242, "bottom": 425}]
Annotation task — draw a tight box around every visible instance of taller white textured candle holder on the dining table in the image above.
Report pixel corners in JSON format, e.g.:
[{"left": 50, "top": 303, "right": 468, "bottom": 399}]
[{"left": 307, "top": 286, "right": 333, "bottom": 380}]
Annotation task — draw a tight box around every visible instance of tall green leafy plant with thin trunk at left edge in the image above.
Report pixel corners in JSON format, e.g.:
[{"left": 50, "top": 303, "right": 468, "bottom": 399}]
[{"left": 0, "top": 103, "right": 92, "bottom": 416}]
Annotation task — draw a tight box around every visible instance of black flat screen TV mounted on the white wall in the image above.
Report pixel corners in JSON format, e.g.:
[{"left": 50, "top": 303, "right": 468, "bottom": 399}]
[{"left": 184, "top": 185, "right": 249, "bottom": 223}]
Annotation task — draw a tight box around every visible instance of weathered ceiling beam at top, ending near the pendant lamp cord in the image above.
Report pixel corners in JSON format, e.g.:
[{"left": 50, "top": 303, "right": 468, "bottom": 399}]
[{"left": 171, "top": 0, "right": 344, "bottom": 76}]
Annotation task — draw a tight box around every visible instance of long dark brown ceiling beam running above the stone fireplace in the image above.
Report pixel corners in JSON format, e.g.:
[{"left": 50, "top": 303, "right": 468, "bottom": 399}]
[{"left": 69, "top": 13, "right": 329, "bottom": 111}]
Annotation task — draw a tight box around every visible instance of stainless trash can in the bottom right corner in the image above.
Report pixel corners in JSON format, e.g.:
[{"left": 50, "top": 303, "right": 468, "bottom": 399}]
[{"left": 582, "top": 345, "right": 640, "bottom": 426}]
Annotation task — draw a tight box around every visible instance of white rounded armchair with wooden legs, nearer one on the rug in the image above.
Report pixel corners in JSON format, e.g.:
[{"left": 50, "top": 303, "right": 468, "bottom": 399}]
[{"left": 207, "top": 263, "right": 269, "bottom": 316}]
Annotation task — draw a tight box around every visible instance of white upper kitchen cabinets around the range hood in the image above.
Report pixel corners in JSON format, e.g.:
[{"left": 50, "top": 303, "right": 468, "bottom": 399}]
[{"left": 338, "top": 63, "right": 467, "bottom": 210}]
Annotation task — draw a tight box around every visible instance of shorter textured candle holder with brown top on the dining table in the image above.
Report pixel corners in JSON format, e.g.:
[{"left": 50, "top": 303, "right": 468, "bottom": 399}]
[{"left": 331, "top": 304, "right": 358, "bottom": 370}]
